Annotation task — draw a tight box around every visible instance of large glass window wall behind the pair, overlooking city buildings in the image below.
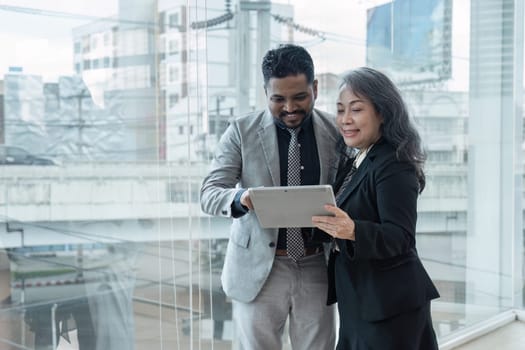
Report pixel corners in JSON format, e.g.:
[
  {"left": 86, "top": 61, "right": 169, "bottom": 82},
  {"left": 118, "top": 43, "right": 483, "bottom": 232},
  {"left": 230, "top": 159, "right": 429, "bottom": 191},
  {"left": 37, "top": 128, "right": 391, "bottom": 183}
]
[{"left": 0, "top": 0, "right": 525, "bottom": 350}]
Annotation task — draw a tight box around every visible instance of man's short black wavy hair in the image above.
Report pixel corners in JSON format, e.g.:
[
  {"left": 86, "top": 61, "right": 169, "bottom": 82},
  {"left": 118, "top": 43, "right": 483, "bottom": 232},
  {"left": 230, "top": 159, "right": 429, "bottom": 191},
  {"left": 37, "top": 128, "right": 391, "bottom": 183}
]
[{"left": 262, "top": 44, "right": 314, "bottom": 86}]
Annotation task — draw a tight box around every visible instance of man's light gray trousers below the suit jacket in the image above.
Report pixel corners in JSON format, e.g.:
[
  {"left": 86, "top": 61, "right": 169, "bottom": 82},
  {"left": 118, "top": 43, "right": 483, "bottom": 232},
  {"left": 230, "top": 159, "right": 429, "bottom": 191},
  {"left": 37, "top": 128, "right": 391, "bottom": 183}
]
[{"left": 233, "top": 253, "right": 336, "bottom": 350}]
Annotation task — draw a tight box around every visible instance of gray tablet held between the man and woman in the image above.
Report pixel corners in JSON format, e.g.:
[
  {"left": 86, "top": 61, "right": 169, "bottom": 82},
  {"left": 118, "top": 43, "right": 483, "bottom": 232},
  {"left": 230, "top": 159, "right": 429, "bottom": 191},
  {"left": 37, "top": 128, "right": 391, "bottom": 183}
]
[{"left": 249, "top": 185, "right": 335, "bottom": 228}]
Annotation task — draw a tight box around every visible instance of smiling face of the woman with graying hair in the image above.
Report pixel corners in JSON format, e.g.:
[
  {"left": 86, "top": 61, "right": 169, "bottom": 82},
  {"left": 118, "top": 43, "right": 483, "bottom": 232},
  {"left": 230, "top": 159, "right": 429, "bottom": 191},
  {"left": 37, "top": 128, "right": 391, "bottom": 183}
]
[{"left": 336, "top": 87, "right": 383, "bottom": 149}]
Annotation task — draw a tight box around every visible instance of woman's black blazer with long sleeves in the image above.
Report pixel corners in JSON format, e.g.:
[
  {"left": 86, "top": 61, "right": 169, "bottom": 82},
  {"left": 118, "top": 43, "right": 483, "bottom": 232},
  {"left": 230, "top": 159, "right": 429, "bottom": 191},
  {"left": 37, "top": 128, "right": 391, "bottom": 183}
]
[{"left": 328, "top": 140, "right": 439, "bottom": 321}]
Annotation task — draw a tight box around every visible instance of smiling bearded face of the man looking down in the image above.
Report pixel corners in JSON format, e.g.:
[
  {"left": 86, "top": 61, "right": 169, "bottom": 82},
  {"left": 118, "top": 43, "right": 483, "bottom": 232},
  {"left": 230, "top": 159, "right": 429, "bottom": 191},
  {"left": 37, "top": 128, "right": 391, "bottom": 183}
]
[{"left": 265, "top": 74, "right": 317, "bottom": 128}]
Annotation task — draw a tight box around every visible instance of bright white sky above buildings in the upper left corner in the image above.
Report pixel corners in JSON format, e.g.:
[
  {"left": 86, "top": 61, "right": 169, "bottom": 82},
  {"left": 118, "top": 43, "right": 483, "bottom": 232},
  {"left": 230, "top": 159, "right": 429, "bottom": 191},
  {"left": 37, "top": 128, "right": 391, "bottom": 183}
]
[{"left": 0, "top": 0, "right": 117, "bottom": 80}]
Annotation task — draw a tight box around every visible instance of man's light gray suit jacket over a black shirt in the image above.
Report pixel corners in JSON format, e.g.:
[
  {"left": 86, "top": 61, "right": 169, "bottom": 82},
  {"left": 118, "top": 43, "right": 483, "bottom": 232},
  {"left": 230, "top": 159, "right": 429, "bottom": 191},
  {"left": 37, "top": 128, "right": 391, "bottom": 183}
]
[{"left": 200, "top": 110, "right": 339, "bottom": 302}]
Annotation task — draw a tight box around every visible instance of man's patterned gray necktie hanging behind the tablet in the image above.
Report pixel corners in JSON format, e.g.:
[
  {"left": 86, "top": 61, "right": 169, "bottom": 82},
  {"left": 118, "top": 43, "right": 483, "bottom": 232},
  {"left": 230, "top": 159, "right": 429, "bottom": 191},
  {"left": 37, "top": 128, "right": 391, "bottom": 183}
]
[{"left": 286, "top": 128, "right": 304, "bottom": 261}]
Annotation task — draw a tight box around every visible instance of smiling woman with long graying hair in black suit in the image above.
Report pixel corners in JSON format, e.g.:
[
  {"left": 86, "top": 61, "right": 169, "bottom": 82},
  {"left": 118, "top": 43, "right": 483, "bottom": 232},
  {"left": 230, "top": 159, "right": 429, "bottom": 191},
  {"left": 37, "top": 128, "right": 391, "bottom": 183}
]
[{"left": 312, "top": 67, "right": 439, "bottom": 350}]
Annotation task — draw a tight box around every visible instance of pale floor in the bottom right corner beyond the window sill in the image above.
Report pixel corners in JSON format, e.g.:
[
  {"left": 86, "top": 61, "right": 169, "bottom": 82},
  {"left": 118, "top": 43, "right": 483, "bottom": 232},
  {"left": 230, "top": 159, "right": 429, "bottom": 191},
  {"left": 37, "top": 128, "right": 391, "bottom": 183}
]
[{"left": 448, "top": 321, "right": 525, "bottom": 350}]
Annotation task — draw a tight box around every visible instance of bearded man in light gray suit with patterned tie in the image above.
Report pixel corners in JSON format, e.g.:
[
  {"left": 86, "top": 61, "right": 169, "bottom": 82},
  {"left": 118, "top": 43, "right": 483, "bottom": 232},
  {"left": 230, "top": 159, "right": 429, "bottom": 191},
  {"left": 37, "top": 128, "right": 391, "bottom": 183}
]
[{"left": 201, "top": 45, "right": 338, "bottom": 350}]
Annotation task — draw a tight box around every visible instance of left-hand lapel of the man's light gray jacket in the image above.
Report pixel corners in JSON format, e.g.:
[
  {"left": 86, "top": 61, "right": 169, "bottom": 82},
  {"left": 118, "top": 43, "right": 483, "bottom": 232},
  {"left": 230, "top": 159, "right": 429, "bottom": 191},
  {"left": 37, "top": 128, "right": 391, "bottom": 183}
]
[{"left": 257, "top": 110, "right": 281, "bottom": 186}]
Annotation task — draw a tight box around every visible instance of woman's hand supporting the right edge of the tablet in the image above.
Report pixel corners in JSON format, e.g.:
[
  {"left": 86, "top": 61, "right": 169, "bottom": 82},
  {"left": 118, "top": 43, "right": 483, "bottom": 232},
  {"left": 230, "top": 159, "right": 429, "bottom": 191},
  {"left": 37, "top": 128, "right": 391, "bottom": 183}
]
[{"left": 312, "top": 204, "right": 355, "bottom": 241}]
